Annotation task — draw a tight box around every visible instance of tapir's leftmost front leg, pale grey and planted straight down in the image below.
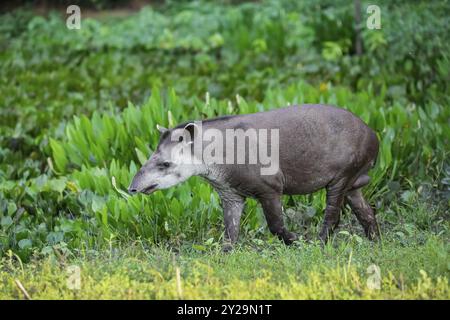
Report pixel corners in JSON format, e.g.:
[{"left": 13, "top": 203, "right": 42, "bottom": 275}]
[{"left": 219, "top": 193, "right": 245, "bottom": 251}]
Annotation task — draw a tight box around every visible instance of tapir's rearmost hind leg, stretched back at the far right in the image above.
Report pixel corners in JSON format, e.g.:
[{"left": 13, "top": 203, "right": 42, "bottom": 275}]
[{"left": 346, "top": 189, "right": 379, "bottom": 240}]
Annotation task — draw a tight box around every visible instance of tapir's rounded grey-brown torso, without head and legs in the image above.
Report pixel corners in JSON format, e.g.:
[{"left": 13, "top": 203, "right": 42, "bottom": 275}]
[{"left": 194, "top": 105, "right": 378, "bottom": 197}]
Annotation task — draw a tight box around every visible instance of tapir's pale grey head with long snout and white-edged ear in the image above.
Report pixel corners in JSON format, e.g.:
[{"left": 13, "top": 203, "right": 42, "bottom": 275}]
[{"left": 128, "top": 123, "right": 200, "bottom": 194}]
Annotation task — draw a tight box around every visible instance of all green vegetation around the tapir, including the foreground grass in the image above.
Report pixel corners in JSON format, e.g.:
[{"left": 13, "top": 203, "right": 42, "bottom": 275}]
[{"left": 0, "top": 0, "right": 450, "bottom": 298}]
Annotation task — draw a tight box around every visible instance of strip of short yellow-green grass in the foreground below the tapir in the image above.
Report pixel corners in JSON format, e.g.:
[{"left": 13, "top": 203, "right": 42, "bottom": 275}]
[{"left": 0, "top": 237, "right": 450, "bottom": 299}]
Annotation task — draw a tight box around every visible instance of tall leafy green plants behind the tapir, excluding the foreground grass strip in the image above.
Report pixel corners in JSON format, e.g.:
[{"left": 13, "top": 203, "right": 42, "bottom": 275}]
[{"left": 0, "top": 0, "right": 450, "bottom": 295}]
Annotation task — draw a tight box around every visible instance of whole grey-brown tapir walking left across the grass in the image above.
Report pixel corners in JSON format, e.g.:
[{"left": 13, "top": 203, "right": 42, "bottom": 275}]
[{"left": 128, "top": 104, "right": 379, "bottom": 251}]
